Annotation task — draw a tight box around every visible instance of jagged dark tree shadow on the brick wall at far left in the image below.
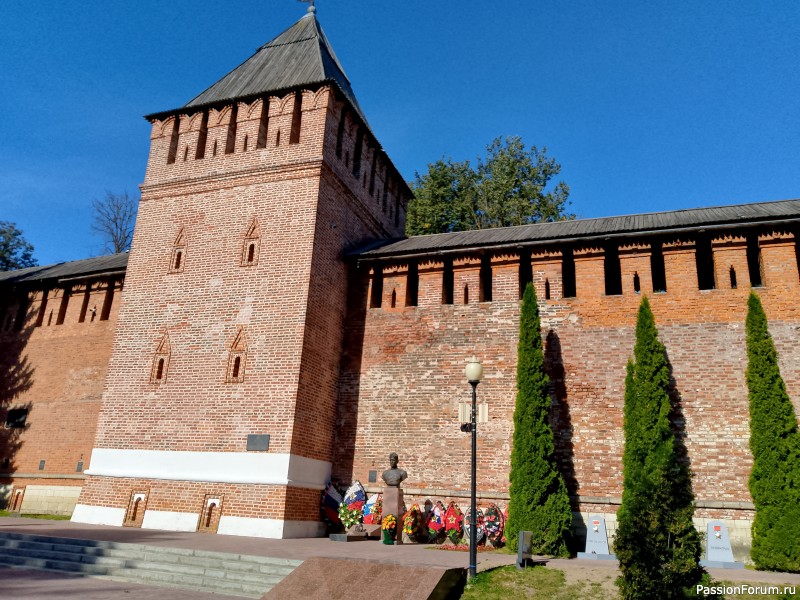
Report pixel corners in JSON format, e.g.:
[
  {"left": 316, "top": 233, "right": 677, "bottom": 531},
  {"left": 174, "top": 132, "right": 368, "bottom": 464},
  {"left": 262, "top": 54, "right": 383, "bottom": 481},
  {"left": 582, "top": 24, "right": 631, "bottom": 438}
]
[{"left": 0, "top": 312, "right": 34, "bottom": 508}]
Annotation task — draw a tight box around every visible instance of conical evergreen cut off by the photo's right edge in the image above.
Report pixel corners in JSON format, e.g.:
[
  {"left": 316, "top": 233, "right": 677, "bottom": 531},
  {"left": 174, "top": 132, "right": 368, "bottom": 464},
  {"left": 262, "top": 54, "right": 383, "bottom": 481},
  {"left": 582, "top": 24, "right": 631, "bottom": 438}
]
[{"left": 745, "top": 292, "right": 800, "bottom": 572}]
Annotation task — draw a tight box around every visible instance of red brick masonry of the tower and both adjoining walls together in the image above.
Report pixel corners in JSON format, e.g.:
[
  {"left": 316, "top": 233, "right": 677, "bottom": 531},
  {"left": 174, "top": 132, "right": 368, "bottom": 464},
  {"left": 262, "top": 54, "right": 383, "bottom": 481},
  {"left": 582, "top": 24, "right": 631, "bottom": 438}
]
[{"left": 0, "top": 19, "right": 800, "bottom": 559}]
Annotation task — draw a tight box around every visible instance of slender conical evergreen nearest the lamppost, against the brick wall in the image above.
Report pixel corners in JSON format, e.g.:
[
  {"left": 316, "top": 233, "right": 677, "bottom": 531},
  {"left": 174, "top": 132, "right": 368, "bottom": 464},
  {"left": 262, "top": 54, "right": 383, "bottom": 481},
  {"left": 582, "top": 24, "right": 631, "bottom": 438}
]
[{"left": 506, "top": 283, "right": 572, "bottom": 556}]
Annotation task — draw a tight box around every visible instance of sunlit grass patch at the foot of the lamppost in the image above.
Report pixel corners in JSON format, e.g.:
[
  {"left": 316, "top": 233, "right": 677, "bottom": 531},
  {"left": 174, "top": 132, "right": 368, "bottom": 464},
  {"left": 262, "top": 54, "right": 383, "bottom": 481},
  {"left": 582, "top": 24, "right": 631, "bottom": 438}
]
[{"left": 461, "top": 567, "right": 613, "bottom": 600}]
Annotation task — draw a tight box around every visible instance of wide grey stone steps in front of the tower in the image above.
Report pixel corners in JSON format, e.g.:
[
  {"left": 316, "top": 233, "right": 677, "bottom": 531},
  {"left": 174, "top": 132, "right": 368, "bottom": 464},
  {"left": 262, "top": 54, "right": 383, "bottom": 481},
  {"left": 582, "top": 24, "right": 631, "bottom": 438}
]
[{"left": 0, "top": 533, "right": 303, "bottom": 598}]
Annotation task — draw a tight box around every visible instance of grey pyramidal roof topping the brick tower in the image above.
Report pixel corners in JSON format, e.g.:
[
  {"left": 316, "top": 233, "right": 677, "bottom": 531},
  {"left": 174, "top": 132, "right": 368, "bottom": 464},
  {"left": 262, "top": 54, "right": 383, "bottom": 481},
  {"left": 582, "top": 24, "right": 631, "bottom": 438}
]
[{"left": 177, "top": 7, "right": 367, "bottom": 123}]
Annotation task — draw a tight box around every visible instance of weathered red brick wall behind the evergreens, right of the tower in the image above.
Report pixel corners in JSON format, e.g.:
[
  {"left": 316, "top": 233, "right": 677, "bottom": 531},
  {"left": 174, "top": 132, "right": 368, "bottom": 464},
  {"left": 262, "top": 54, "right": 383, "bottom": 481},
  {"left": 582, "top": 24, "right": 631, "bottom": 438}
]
[{"left": 334, "top": 233, "right": 800, "bottom": 516}]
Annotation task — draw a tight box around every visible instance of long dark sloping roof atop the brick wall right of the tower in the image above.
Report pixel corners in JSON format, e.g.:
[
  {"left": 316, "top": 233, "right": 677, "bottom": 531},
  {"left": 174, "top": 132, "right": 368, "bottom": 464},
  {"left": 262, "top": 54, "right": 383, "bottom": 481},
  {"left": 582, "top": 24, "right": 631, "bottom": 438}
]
[{"left": 353, "top": 200, "right": 800, "bottom": 259}]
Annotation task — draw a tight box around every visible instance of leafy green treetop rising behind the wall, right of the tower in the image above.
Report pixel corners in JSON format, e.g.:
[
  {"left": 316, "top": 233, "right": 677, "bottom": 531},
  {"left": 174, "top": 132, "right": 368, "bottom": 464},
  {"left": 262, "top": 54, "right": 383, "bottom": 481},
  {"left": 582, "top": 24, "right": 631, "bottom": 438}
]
[{"left": 406, "top": 137, "right": 574, "bottom": 235}]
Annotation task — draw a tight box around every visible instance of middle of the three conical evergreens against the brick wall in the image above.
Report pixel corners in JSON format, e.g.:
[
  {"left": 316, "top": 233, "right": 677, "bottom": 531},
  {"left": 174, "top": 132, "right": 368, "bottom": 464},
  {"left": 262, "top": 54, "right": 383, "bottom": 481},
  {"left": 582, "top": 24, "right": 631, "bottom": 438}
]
[{"left": 614, "top": 298, "right": 704, "bottom": 600}]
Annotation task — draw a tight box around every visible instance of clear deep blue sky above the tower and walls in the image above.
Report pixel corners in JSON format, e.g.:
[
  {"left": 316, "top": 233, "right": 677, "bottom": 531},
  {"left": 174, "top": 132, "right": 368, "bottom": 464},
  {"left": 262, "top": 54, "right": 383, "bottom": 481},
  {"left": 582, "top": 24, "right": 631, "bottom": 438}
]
[{"left": 0, "top": 0, "right": 800, "bottom": 264}]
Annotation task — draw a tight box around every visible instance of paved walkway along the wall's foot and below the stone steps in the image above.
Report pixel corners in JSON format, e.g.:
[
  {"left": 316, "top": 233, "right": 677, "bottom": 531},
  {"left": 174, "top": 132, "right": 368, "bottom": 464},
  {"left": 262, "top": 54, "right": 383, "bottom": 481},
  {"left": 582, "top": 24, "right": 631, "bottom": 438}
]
[{"left": 0, "top": 517, "right": 800, "bottom": 600}]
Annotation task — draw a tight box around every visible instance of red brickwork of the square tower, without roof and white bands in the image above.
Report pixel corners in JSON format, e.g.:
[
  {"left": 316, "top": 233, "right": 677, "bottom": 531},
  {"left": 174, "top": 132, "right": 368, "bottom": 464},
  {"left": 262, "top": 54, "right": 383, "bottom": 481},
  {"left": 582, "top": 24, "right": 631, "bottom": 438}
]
[{"left": 81, "top": 87, "right": 412, "bottom": 519}]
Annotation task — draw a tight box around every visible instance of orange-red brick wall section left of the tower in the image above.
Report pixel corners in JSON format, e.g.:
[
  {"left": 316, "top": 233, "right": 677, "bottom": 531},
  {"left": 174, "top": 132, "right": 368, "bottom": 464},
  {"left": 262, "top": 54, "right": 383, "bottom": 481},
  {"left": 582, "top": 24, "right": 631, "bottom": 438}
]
[{"left": 0, "top": 277, "right": 122, "bottom": 494}]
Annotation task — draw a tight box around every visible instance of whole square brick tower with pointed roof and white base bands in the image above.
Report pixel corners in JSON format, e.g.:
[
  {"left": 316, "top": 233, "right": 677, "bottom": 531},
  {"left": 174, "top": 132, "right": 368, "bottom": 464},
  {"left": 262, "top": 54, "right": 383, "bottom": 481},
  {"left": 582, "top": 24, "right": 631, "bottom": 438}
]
[{"left": 73, "top": 7, "right": 410, "bottom": 538}]
